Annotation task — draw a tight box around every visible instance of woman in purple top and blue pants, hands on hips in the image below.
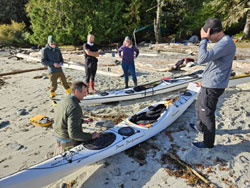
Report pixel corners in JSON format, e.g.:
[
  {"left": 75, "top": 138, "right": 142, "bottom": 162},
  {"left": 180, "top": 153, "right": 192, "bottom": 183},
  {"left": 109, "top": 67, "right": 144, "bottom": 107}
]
[{"left": 118, "top": 36, "right": 139, "bottom": 88}]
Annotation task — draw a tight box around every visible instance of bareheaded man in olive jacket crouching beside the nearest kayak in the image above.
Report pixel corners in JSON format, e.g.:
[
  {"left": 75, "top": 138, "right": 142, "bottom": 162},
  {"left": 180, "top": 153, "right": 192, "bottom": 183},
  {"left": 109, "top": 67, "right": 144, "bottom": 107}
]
[{"left": 53, "top": 81, "right": 99, "bottom": 155}]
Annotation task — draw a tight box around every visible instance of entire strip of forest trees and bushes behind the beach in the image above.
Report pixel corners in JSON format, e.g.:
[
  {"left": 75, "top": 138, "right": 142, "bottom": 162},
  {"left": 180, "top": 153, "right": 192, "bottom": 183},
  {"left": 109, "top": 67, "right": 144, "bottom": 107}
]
[{"left": 0, "top": 0, "right": 250, "bottom": 47}]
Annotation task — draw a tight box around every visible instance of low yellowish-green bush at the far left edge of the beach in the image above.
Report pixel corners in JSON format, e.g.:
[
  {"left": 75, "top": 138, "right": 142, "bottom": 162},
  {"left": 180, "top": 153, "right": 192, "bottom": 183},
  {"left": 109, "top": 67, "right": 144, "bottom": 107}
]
[{"left": 0, "top": 21, "right": 27, "bottom": 46}]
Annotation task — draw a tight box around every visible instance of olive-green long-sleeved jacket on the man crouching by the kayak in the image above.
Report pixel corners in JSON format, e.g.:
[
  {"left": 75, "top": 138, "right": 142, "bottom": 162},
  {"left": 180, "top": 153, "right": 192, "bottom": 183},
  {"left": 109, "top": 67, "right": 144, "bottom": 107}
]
[{"left": 53, "top": 95, "right": 92, "bottom": 141}]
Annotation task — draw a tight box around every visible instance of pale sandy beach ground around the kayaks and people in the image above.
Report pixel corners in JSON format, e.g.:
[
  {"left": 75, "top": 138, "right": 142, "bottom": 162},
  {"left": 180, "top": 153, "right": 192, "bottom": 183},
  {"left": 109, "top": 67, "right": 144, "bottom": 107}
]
[{"left": 0, "top": 44, "right": 250, "bottom": 188}]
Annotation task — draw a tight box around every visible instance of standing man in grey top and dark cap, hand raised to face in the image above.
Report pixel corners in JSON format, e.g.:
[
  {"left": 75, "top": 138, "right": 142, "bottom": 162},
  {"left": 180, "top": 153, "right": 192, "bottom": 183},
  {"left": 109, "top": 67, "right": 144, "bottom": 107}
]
[{"left": 190, "top": 18, "right": 236, "bottom": 148}]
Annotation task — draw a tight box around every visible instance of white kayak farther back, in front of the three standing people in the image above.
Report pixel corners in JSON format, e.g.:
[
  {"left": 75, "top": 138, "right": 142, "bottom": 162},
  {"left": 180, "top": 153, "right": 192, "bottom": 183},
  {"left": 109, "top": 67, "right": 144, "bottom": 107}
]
[{"left": 81, "top": 70, "right": 203, "bottom": 105}]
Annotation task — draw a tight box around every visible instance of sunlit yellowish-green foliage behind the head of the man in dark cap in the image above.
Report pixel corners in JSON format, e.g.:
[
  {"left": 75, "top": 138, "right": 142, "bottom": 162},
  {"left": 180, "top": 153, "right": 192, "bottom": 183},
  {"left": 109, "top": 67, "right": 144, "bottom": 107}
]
[{"left": 180, "top": 0, "right": 250, "bottom": 38}]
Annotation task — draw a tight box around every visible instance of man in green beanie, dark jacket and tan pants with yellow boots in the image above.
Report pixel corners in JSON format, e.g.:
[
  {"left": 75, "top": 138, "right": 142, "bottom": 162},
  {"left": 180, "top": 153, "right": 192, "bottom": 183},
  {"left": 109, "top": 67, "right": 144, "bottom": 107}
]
[{"left": 42, "top": 35, "right": 71, "bottom": 106}]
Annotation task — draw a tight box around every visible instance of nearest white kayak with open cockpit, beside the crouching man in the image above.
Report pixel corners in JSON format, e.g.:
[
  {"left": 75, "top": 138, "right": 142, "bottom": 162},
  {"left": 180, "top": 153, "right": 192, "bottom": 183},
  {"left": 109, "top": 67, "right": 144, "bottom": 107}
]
[{"left": 0, "top": 83, "right": 199, "bottom": 188}]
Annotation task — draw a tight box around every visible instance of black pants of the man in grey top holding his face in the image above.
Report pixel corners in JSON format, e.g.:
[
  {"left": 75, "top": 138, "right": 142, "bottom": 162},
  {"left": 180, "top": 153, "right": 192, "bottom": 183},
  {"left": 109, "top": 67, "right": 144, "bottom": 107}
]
[{"left": 195, "top": 87, "right": 225, "bottom": 148}]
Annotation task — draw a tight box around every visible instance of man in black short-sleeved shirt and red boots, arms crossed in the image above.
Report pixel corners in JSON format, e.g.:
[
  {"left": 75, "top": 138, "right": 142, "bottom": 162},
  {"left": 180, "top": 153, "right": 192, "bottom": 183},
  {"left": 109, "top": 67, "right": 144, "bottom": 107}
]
[{"left": 83, "top": 34, "right": 99, "bottom": 92}]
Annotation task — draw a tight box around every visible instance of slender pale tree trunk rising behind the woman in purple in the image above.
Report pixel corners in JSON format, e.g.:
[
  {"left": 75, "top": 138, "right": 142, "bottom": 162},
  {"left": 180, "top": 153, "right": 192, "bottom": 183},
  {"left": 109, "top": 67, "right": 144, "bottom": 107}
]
[{"left": 154, "top": 0, "right": 162, "bottom": 44}]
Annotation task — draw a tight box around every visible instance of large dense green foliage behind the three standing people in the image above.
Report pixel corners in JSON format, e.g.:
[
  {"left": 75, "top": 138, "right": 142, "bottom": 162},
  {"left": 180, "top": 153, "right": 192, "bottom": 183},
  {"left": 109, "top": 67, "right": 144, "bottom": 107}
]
[{"left": 27, "top": 0, "right": 154, "bottom": 45}]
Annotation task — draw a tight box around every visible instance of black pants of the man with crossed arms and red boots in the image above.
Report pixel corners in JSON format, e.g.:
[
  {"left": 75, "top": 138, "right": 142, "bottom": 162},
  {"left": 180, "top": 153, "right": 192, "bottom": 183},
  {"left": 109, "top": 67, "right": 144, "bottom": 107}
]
[{"left": 85, "top": 57, "right": 97, "bottom": 83}]
